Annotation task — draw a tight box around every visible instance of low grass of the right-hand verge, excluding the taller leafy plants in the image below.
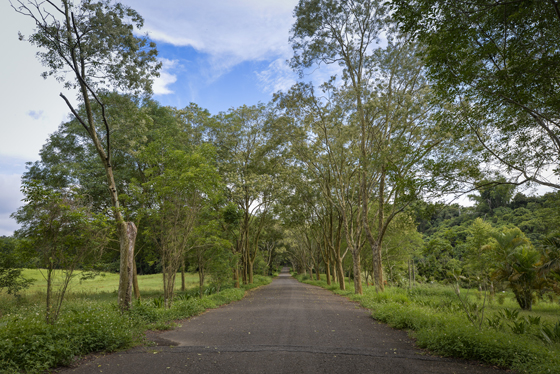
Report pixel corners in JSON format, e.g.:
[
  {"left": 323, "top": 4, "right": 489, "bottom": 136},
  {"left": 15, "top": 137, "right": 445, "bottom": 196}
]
[{"left": 296, "top": 275, "right": 560, "bottom": 374}]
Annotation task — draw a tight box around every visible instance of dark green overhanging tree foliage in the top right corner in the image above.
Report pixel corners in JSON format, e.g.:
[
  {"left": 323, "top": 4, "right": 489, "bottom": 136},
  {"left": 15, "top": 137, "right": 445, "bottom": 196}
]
[{"left": 392, "top": 0, "right": 560, "bottom": 189}]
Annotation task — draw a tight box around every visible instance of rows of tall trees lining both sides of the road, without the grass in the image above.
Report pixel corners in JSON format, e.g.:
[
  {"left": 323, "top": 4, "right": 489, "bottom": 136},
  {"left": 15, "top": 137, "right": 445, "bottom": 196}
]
[{"left": 5, "top": 0, "right": 560, "bottom": 316}]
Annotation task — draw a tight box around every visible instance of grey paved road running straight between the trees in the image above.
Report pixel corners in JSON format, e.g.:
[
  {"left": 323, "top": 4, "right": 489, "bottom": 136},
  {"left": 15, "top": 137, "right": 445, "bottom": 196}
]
[{"left": 65, "top": 272, "right": 503, "bottom": 374}]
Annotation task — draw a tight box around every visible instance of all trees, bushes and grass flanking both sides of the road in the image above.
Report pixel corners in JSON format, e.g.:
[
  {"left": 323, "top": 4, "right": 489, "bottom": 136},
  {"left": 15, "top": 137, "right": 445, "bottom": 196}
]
[{"left": 0, "top": 0, "right": 560, "bottom": 373}]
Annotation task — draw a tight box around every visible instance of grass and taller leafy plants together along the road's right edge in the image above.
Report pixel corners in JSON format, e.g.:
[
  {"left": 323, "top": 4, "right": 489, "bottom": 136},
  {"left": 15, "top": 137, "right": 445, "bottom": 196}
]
[{"left": 294, "top": 274, "right": 560, "bottom": 374}]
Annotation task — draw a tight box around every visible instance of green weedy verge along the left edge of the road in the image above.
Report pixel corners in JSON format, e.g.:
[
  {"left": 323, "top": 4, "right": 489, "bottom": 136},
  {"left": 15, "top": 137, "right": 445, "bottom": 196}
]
[{"left": 0, "top": 275, "right": 271, "bottom": 373}]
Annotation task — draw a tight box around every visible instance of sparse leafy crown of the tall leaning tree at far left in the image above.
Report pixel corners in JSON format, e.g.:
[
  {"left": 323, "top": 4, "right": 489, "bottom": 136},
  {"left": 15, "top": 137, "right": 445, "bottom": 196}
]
[{"left": 14, "top": 0, "right": 161, "bottom": 94}]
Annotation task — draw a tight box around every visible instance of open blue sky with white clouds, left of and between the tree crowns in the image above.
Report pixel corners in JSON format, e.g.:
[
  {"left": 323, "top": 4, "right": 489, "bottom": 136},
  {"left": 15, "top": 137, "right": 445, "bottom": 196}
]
[{"left": 0, "top": 0, "right": 310, "bottom": 235}]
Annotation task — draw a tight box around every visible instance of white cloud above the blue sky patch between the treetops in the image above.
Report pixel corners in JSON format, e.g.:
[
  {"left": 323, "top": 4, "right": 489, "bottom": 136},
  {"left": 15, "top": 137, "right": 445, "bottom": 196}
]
[{"left": 125, "top": 0, "right": 297, "bottom": 76}]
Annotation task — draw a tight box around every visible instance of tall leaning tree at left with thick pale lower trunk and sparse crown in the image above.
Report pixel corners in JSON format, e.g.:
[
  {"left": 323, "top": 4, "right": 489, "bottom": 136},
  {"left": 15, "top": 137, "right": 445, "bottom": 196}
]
[{"left": 12, "top": 0, "right": 161, "bottom": 310}]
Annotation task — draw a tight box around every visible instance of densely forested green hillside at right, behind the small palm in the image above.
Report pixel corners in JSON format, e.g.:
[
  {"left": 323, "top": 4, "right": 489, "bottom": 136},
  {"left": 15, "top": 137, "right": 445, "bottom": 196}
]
[{"left": 416, "top": 190, "right": 560, "bottom": 280}]
